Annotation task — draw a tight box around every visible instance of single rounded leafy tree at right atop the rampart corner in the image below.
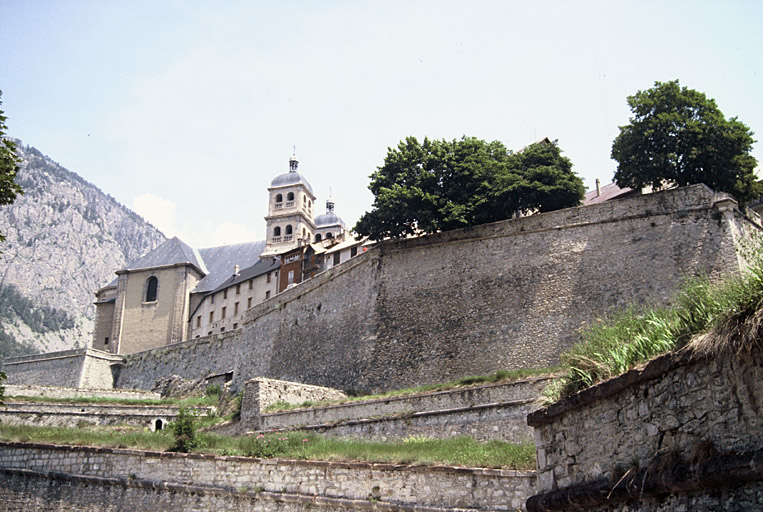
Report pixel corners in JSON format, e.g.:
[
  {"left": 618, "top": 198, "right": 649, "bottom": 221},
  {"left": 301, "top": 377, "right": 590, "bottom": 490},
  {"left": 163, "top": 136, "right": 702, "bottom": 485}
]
[{"left": 612, "top": 80, "right": 763, "bottom": 203}]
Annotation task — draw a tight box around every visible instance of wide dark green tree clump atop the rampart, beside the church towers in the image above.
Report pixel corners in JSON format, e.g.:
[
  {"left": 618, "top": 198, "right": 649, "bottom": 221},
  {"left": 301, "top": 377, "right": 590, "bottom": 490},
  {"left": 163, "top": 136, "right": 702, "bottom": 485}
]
[{"left": 354, "top": 137, "right": 584, "bottom": 240}]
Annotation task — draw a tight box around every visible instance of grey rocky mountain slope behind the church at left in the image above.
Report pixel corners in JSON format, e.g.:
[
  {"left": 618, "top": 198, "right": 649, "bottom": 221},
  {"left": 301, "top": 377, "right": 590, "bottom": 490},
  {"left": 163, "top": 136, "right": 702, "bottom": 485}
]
[{"left": 0, "top": 141, "right": 165, "bottom": 357}]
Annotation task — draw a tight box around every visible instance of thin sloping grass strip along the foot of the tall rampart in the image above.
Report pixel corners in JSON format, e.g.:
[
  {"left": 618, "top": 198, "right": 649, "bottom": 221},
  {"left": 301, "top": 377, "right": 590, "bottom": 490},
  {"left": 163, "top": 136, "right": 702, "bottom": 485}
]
[{"left": 263, "top": 366, "right": 564, "bottom": 413}]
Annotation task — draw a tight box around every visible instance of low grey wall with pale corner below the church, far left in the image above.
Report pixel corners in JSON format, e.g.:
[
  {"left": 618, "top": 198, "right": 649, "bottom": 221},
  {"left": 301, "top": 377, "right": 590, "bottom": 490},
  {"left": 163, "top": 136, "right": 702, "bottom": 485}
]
[{"left": 2, "top": 348, "right": 122, "bottom": 388}]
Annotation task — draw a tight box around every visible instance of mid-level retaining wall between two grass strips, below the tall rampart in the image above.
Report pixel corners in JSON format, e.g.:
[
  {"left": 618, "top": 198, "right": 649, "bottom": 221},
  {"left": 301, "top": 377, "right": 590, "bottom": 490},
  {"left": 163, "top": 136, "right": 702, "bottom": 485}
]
[{"left": 255, "top": 378, "right": 549, "bottom": 442}]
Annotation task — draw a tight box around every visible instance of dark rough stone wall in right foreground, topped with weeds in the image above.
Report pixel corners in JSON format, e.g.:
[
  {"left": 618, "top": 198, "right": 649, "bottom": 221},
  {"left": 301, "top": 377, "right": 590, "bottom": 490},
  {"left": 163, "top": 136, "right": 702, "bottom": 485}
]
[{"left": 528, "top": 347, "right": 763, "bottom": 511}]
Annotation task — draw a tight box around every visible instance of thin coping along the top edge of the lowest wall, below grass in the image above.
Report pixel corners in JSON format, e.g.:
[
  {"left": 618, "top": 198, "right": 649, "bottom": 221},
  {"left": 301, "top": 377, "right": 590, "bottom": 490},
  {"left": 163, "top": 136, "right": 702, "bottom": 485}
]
[{"left": 0, "top": 441, "right": 535, "bottom": 478}]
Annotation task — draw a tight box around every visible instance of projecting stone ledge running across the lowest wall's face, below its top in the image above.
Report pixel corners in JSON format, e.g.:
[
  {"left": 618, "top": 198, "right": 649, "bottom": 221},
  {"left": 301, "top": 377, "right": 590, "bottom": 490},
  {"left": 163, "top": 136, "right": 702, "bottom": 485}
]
[{"left": 0, "top": 468, "right": 497, "bottom": 512}]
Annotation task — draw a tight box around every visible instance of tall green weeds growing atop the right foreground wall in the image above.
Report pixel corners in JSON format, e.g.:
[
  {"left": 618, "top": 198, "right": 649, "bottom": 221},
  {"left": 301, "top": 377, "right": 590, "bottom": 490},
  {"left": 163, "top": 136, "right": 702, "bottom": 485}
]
[{"left": 545, "top": 238, "right": 763, "bottom": 401}]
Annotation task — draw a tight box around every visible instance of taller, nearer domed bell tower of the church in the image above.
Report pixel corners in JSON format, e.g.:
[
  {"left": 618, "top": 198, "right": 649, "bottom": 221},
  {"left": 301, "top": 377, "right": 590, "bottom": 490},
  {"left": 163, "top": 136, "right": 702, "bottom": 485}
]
[{"left": 260, "top": 155, "right": 316, "bottom": 258}]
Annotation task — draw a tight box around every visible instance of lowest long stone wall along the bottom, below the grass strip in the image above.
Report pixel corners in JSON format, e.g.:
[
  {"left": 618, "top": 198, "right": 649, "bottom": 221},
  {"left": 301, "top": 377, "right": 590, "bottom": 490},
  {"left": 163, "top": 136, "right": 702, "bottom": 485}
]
[{"left": 0, "top": 443, "right": 534, "bottom": 512}]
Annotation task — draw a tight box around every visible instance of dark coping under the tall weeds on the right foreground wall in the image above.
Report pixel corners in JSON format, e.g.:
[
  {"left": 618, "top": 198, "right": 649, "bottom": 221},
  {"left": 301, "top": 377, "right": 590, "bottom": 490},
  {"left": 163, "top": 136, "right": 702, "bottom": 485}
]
[{"left": 527, "top": 351, "right": 699, "bottom": 427}]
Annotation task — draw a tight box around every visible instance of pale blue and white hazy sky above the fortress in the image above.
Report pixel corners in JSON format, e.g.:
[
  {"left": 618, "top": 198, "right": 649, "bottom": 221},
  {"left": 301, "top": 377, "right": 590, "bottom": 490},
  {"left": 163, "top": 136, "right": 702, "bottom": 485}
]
[{"left": 0, "top": 0, "right": 763, "bottom": 248}]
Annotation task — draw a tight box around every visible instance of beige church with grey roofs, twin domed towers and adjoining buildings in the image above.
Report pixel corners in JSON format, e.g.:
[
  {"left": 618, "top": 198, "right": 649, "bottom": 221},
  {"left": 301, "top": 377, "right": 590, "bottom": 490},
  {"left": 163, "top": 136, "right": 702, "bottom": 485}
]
[{"left": 92, "top": 156, "right": 367, "bottom": 354}]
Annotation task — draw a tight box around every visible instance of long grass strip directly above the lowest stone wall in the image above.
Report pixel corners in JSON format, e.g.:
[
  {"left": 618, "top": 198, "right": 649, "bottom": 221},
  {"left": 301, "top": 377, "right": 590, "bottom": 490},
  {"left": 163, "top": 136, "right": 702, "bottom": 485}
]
[{"left": 0, "top": 425, "right": 535, "bottom": 470}]
